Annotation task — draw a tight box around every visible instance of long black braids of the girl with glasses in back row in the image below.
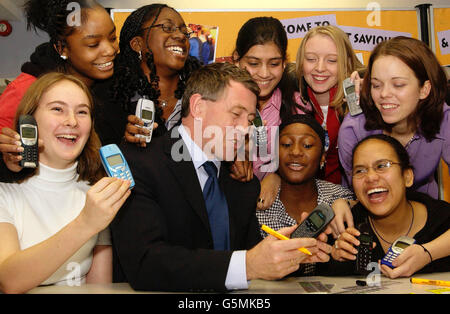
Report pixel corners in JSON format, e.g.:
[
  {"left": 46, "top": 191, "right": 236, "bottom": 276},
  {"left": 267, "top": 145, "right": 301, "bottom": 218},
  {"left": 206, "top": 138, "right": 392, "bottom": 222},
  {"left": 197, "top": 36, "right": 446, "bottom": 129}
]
[{"left": 111, "top": 3, "right": 201, "bottom": 129}]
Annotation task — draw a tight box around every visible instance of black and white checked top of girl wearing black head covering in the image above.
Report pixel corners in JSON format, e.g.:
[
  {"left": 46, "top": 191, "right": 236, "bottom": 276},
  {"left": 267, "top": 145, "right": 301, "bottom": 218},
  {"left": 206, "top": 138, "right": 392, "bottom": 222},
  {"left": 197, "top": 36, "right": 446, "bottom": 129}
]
[{"left": 256, "top": 179, "right": 354, "bottom": 275}]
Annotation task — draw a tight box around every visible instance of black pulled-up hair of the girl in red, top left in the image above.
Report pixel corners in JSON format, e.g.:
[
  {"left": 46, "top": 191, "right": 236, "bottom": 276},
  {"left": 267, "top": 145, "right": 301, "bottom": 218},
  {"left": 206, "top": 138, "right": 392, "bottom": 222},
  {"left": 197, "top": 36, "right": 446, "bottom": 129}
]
[{"left": 23, "top": 0, "right": 101, "bottom": 72}]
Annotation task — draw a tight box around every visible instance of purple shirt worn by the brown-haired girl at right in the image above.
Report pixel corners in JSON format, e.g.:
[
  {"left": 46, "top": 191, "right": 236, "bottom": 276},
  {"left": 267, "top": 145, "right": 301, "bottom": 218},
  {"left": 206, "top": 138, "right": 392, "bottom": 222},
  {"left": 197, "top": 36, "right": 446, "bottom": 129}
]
[{"left": 338, "top": 104, "right": 450, "bottom": 199}]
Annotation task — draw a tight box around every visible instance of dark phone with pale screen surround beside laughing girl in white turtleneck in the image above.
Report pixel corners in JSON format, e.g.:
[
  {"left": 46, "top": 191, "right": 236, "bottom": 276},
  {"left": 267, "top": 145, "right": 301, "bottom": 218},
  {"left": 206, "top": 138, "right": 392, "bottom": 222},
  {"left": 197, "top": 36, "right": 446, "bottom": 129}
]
[{"left": 17, "top": 115, "right": 39, "bottom": 168}]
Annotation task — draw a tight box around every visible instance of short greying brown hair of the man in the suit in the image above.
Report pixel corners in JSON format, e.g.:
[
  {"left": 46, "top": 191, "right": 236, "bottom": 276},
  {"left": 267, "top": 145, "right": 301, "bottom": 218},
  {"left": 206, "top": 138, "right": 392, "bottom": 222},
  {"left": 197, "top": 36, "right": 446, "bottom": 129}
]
[{"left": 181, "top": 63, "right": 260, "bottom": 117}]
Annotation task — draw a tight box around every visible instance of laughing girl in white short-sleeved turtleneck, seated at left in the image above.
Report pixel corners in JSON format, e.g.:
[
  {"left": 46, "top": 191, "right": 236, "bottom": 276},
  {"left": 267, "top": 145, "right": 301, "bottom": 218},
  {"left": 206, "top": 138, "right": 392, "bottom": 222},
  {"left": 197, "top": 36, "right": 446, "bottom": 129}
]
[{"left": 0, "top": 73, "right": 130, "bottom": 293}]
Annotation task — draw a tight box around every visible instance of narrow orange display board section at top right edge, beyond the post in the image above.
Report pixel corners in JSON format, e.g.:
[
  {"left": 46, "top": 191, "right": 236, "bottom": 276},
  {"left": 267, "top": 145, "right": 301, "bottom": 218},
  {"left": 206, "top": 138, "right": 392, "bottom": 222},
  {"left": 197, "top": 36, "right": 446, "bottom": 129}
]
[{"left": 432, "top": 8, "right": 450, "bottom": 66}]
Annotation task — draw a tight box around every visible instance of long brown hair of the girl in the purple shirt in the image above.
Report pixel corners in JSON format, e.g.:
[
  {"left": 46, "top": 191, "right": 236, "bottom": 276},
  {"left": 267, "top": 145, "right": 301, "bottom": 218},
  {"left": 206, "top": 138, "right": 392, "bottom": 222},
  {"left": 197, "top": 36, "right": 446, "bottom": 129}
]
[{"left": 361, "top": 36, "right": 447, "bottom": 141}]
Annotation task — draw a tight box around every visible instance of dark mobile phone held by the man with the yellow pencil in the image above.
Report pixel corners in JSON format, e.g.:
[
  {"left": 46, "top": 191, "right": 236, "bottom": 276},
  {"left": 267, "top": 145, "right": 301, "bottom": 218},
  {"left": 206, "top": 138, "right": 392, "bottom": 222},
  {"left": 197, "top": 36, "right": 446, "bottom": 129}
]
[{"left": 291, "top": 203, "right": 334, "bottom": 238}]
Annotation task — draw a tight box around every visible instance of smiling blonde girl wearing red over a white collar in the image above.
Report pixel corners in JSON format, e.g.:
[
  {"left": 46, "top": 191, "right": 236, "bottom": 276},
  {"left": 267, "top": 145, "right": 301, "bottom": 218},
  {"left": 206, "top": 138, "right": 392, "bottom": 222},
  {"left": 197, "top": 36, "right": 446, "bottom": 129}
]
[{"left": 297, "top": 25, "right": 364, "bottom": 184}]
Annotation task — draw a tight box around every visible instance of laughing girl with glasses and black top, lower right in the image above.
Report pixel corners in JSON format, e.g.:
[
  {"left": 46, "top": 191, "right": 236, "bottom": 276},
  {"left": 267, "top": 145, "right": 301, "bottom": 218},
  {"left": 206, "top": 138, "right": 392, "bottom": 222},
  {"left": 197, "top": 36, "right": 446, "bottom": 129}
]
[{"left": 328, "top": 134, "right": 450, "bottom": 278}]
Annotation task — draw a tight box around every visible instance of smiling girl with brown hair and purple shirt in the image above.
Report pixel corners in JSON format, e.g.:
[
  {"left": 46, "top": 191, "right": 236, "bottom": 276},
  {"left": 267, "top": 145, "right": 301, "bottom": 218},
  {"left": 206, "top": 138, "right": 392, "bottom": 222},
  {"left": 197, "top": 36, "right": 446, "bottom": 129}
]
[{"left": 338, "top": 37, "right": 450, "bottom": 198}]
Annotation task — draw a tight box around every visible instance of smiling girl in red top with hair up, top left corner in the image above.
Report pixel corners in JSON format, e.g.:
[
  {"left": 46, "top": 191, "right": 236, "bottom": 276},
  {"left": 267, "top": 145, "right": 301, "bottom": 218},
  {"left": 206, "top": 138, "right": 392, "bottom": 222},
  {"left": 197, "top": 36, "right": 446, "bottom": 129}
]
[{"left": 0, "top": 0, "right": 118, "bottom": 173}]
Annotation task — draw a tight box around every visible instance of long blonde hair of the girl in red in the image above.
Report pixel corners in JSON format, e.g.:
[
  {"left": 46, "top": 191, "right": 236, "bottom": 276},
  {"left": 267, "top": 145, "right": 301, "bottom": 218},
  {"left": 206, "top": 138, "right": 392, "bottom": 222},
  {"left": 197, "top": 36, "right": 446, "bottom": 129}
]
[{"left": 296, "top": 25, "right": 365, "bottom": 118}]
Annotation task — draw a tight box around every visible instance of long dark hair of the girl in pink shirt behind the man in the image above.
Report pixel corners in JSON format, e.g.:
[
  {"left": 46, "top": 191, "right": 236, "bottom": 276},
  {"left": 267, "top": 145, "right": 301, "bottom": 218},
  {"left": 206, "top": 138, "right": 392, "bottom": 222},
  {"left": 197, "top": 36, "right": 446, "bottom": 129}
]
[{"left": 233, "top": 16, "right": 303, "bottom": 121}]
